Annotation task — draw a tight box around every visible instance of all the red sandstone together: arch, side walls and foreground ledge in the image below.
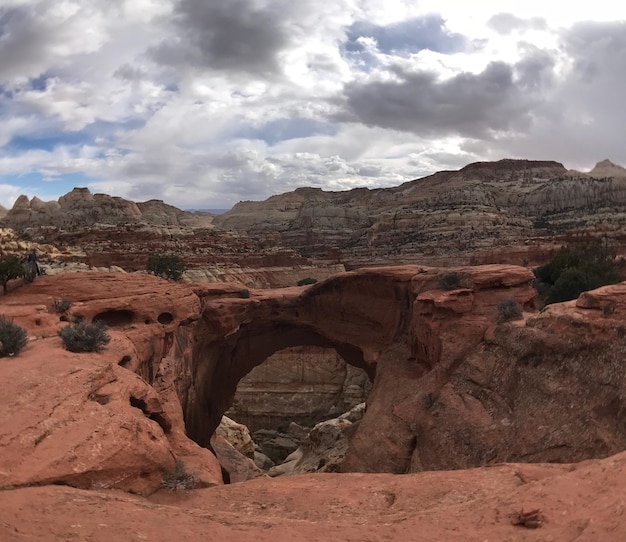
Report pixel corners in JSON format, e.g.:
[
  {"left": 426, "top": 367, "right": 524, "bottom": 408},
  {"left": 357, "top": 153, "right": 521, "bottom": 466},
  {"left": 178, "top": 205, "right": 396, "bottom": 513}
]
[{"left": 0, "top": 266, "right": 626, "bottom": 542}]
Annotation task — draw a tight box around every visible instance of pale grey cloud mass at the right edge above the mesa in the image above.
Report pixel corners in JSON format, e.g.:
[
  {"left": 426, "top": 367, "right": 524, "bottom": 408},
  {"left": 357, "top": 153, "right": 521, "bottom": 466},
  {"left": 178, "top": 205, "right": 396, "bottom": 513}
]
[{"left": 480, "top": 21, "right": 626, "bottom": 168}]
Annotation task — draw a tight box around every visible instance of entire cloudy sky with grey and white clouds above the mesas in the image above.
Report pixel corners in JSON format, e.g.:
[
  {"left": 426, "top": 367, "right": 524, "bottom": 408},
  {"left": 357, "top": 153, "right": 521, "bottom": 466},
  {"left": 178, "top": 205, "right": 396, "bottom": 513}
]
[{"left": 0, "top": 0, "right": 626, "bottom": 209}]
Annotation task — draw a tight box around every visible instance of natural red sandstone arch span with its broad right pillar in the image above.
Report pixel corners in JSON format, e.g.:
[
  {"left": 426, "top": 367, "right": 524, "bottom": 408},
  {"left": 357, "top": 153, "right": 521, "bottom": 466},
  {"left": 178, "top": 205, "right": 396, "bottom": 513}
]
[{"left": 178, "top": 265, "right": 535, "bottom": 473}]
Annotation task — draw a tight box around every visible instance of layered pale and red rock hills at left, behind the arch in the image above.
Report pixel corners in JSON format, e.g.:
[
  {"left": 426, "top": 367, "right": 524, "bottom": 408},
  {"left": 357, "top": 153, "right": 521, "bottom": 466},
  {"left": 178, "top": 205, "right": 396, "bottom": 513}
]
[{"left": 0, "top": 188, "right": 345, "bottom": 288}]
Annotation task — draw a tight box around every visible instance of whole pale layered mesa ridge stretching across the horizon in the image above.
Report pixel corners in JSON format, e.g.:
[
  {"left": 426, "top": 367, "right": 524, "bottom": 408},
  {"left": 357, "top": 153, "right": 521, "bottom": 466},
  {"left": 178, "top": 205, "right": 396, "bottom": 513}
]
[{"left": 0, "top": 158, "right": 626, "bottom": 268}]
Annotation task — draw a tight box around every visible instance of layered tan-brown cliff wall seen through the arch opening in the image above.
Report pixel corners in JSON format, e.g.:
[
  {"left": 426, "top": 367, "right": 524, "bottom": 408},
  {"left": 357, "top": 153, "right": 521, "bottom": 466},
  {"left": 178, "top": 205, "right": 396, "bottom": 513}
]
[{"left": 226, "top": 346, "right": 371, "bottom": 470}]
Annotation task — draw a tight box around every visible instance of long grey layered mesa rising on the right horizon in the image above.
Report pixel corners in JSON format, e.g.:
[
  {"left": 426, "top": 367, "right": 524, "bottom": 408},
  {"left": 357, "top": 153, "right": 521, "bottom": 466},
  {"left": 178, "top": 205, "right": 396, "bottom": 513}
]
[{"left": 214, "top": 160, "right": 626, "bottom": 267}]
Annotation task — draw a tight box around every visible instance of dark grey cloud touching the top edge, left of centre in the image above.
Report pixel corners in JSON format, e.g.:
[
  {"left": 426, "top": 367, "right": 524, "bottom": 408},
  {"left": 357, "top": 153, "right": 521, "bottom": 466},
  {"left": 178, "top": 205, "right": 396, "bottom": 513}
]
[{"left": 152, "top": 0, "right": 296, "bottom": 74}]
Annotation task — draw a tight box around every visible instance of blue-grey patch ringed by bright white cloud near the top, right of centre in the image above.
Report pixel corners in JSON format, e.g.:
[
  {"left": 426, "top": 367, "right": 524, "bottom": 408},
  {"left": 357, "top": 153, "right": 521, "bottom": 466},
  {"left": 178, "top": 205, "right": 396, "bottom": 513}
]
[{"left": 344, "top": 15, "right": 468, "bottom": 55}]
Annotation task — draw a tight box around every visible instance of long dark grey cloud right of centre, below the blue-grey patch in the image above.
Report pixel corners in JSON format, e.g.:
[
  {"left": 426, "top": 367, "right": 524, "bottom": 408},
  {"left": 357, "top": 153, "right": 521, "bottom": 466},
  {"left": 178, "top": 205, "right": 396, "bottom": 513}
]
[{"left": 342, "top": 62, "right": 542, "bottom": 138}]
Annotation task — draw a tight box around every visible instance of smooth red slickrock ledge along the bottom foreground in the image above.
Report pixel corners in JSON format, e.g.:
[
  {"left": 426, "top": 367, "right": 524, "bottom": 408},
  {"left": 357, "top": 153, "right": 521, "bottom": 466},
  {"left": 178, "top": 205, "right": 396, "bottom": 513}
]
[{"left": 0, "top": 454, "right": 626, "bottom": 542}]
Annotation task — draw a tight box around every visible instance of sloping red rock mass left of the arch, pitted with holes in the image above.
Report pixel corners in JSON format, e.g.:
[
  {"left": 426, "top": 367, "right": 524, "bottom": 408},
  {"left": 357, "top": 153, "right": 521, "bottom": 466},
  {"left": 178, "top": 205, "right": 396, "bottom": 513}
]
[{"left": 0, "top": 273, "right": 222, "bottom": 494}]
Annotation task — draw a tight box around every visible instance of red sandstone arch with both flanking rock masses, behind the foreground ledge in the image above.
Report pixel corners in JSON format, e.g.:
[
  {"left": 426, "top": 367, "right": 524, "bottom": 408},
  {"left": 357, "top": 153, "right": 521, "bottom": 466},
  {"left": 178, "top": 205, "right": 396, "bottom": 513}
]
[{"left": 0, "top": 265, "right": 626, "bottom": 493}]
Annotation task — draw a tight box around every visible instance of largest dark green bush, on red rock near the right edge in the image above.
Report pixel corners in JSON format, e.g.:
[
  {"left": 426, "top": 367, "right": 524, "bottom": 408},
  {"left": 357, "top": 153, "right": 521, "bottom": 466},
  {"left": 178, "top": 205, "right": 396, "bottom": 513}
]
[{"left": 533, "top": 241, "right": 624, "bottom": 304}]
